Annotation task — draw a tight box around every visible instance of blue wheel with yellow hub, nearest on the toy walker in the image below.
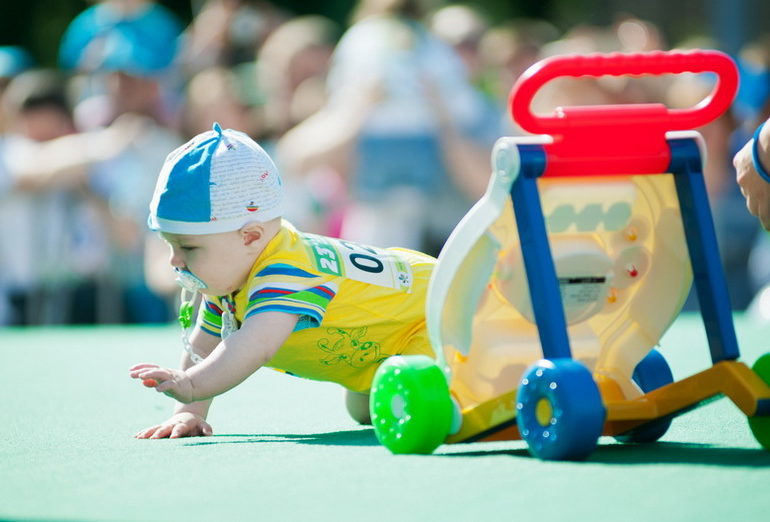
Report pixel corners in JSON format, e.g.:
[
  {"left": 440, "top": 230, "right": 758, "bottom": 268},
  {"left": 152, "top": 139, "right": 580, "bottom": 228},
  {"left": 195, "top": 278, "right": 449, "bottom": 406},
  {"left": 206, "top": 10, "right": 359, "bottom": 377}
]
[{"left": 516, "top": 359, "right": 606, "bottom": 460}]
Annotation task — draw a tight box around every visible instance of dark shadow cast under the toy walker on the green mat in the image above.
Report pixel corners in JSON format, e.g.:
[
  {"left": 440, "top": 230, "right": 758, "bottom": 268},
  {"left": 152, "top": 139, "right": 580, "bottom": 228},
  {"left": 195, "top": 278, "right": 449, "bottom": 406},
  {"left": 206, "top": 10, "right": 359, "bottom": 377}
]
[{"left": 440, "top": 442, "right": 770, "bottom": 468}]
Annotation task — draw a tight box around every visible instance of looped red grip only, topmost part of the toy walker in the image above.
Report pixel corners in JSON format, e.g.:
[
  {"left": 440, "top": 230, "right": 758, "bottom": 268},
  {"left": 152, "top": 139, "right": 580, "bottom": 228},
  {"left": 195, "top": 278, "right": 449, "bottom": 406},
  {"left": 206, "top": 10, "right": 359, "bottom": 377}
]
[{"left": 510, "top": 50, "right": 738, "bottom": 134}]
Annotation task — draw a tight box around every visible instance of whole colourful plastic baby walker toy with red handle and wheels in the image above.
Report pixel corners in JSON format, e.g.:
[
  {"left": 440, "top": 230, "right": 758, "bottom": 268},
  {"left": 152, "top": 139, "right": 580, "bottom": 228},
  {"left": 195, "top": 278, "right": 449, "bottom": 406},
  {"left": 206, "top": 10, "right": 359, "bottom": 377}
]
[{"left": 370, "top": 51, "right": 770, "bottom": 459}]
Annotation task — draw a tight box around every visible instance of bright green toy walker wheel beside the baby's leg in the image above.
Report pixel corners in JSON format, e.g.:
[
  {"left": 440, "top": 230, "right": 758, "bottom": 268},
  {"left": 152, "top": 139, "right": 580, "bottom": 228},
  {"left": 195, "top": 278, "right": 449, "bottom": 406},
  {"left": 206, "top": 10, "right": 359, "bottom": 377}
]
[{"left": 369, "top": 355, "right": 453, "bottom": 454}]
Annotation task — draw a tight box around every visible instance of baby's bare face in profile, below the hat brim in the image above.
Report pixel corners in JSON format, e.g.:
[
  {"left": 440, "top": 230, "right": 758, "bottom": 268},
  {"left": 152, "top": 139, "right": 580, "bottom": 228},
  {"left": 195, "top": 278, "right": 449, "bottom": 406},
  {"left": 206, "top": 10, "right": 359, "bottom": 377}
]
[{"left": 161, "top": 231, "right": 255, "bottom": 296}]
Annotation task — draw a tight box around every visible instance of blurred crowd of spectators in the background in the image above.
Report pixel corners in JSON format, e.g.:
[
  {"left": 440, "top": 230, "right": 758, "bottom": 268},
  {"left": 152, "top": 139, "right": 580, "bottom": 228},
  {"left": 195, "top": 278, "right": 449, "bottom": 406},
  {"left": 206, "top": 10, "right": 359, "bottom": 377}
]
[{"left": 0, "top": 0, "right": 770, "bottom": 325}]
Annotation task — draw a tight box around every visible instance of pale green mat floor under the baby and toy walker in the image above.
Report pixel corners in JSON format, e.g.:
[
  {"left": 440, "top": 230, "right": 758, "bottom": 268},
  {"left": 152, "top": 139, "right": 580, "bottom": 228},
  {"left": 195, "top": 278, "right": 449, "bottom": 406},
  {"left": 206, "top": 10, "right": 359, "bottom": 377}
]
[{"left": 0, "top": 310, "right": 770, "bottom": 522}]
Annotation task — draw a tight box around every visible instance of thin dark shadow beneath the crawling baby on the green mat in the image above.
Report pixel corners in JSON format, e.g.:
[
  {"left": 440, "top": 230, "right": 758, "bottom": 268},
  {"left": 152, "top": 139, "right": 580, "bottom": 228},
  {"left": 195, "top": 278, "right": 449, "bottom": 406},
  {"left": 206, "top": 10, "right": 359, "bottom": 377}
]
[{"left": 185, "top": 428, "right": 379, "bottom": 446}]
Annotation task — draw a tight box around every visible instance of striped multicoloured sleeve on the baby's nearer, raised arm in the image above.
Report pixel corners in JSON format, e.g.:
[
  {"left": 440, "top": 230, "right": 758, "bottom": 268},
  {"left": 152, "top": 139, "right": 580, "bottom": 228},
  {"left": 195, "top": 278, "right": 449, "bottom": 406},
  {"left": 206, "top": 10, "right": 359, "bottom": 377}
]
[{"left": 245, "top": 263, "right": 337, "bottom": 331}]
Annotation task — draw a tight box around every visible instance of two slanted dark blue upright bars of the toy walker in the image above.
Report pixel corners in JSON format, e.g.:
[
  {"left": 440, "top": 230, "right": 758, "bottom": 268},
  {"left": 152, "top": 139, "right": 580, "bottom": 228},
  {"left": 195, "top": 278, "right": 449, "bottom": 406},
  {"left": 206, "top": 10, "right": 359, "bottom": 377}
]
[{"left": 511, "top": 138, "right": 748, "bottom": 372}]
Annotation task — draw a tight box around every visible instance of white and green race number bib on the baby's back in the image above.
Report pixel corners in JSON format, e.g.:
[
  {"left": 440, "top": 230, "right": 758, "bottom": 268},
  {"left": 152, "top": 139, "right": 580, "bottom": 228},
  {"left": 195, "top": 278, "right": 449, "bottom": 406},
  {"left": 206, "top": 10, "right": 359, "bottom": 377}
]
[{"left": 302, "top": 234, "right": 412, "bottom": 292}]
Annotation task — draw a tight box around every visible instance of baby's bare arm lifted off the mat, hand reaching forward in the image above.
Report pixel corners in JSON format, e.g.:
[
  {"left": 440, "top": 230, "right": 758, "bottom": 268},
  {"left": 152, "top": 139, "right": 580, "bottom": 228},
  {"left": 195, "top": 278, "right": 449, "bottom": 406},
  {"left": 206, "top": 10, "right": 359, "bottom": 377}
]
[{"left": 131, "top": 312, "right": 299, "bottom": 403}]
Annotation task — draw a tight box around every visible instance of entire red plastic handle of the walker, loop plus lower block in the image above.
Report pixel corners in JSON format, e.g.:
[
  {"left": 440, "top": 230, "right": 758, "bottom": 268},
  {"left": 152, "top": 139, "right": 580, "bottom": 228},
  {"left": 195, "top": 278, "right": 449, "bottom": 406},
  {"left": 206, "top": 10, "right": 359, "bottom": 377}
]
[{"left": 510, "top": 51, "right": 738, "bottom": 176}]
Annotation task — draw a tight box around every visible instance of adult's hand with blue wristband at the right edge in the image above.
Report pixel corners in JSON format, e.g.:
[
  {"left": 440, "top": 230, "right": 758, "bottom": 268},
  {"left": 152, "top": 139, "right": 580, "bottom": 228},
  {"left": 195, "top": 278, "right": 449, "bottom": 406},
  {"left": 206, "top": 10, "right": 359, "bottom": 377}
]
[{"left": 733, "top": 125, "right": 770, "bottom": 230}]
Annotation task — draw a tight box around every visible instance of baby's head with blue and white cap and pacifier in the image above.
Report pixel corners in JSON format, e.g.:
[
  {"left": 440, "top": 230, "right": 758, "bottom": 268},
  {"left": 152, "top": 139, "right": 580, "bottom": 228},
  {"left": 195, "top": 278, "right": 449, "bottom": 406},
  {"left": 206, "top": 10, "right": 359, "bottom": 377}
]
[{"left": 148, "top": 123, "right": 283, "bottom": 295}]
